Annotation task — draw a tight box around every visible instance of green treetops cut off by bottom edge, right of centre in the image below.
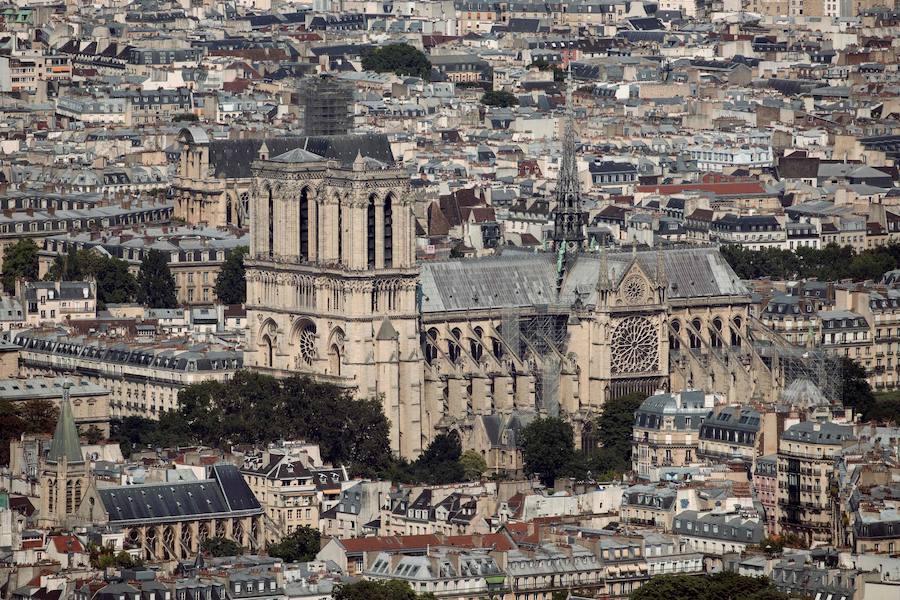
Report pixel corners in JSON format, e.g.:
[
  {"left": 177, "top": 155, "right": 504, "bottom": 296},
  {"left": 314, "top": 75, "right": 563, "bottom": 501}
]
[{"left": 630, "top": 573, "right": 788, "bottom": 600}]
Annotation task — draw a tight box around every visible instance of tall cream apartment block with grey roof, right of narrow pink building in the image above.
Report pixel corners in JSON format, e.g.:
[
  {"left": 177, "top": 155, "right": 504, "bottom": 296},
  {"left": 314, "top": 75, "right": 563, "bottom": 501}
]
[{"left": 777, "top": 421, "right": 855, "bottom": 544}]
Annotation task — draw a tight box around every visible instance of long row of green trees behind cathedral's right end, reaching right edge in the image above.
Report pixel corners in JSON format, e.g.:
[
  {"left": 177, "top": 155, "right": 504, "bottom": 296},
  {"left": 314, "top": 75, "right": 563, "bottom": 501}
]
[{"left": 722, "top": 244, "right": 900, "bottom": 281}]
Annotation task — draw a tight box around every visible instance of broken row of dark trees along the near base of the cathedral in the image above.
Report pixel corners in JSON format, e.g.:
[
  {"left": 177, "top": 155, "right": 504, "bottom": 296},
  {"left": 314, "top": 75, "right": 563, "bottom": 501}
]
[{"left": 111, "top": 371, "right": 643, "bottom": 486}]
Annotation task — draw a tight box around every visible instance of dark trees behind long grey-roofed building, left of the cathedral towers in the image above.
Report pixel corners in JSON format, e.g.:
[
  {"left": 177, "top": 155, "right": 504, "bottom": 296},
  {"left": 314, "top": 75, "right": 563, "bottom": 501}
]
[{"left": 2, "top": 239, "right": 247, "bottom": 310}]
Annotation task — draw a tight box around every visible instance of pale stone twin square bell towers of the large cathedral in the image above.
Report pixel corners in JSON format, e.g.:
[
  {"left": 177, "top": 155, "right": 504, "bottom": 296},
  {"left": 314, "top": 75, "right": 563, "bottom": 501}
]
[{"left": 246, "top": 136, "right": 423, "bottom": 456}]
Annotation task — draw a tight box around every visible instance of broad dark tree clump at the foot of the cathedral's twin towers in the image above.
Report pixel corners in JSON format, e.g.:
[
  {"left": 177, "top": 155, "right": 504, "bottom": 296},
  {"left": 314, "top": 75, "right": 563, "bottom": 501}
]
[{"left": 110, "top": 371, "right": 391, "bottom": 476}]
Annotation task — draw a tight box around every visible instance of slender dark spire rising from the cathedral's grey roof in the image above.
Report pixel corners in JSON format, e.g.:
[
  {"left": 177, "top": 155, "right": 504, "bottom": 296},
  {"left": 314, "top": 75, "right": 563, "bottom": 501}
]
[{"left": 553, "top": 66, "right": 587, "bottom": 253}]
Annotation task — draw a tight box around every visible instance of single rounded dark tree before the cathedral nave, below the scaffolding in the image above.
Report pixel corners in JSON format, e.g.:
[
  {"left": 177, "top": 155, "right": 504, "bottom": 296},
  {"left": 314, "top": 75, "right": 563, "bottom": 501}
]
[{"left": 522, "top": 417, "right": 575, "bottom": 487}]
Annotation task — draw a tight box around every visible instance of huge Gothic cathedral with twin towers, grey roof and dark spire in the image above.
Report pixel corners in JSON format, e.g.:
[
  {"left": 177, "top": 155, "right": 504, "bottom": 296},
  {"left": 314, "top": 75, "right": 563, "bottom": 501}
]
[{"left": 245, "top": 113, "right": 776, "bottom": 460}]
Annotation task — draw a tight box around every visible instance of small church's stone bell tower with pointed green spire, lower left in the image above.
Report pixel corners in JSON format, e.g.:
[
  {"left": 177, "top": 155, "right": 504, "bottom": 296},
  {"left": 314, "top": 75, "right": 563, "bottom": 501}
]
[{"left": 38, "top": 382, "right": 89, "bottom": 527}]
